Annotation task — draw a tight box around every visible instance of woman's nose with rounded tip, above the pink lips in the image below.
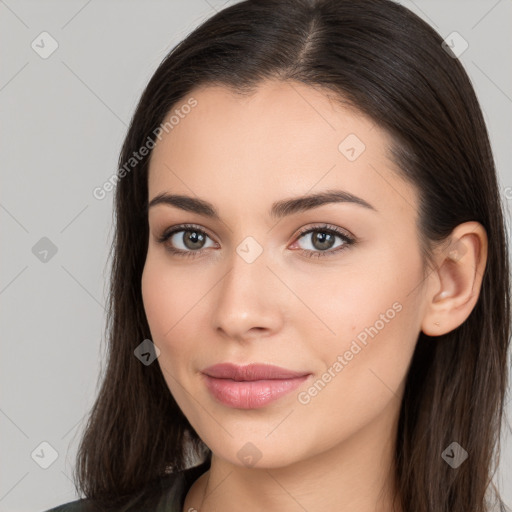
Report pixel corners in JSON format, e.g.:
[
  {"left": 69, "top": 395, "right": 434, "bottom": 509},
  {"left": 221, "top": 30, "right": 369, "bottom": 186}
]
[{"left": 213, "top": 245, "right": 284, "bottom": 342}]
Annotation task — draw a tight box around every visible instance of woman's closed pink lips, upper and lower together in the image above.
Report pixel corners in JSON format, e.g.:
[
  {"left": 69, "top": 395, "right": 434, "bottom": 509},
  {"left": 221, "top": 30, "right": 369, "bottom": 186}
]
[{"left": 203, "top": 363, "right": 310, "bottom": 409}]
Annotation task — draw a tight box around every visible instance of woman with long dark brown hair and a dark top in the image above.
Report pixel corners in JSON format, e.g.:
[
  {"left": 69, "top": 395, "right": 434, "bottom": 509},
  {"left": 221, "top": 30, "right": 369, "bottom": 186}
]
[{"left": 45, "top": 0, "right": 510, "bottom": 512}]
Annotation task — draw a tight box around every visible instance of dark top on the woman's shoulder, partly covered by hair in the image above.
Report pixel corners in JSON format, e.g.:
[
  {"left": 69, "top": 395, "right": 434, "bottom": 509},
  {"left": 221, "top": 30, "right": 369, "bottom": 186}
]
[{"left": 45, "top": 460, "right": 210, "bottom": 512}]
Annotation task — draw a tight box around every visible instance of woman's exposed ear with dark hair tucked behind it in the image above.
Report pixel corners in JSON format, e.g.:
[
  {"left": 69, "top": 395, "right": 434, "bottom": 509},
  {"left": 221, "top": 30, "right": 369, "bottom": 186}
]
[{"left": 421, "top": 221, "right": 487, "bottom": 336}]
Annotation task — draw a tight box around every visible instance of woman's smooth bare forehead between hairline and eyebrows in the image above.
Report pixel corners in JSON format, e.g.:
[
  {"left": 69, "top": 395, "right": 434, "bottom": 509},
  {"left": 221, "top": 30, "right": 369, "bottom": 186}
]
[{"left": 149, "top": 81, "right": 412, "bottom": 220}]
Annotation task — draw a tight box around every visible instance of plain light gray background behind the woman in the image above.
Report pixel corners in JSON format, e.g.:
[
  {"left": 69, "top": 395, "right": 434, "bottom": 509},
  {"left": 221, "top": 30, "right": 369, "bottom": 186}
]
[{"left": 0, "top": 0, "right": 512, "bottom": 512}]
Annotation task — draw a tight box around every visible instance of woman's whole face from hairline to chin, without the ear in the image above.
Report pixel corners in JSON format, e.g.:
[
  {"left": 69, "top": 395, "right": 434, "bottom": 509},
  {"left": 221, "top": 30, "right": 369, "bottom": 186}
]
[{"left": 142, "top": 81, "right": 424, "bottom": 467}]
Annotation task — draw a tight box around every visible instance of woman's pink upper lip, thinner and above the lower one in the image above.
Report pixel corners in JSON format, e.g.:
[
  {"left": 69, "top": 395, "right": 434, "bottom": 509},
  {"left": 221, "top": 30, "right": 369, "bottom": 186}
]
[{"left": 203, "top": 363, "right": 309, "bottom": 381}]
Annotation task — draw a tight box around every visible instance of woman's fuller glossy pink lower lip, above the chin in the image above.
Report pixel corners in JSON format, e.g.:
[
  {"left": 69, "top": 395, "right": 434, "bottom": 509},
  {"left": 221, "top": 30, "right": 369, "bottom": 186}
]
[{"left": 205, "top": 375, "right": 309, "bottom": 409}]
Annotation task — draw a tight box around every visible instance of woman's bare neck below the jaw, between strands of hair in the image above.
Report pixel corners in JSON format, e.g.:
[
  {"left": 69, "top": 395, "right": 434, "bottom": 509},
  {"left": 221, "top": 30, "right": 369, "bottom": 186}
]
[{"left": 183, "top": 401, "right": 400, "bottom": 512}]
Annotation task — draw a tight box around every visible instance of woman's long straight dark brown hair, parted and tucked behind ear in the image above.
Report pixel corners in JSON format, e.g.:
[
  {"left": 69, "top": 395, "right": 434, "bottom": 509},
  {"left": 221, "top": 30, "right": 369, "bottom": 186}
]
[{"left": 75, "top": 0, "right": 510, "bottom": 512}]
